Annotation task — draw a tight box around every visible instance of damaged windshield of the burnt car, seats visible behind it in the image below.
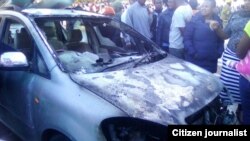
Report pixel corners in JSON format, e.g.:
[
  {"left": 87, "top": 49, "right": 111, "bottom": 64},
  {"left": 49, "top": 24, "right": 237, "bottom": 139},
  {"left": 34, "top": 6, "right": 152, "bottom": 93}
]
[{"left": 35, "top": 17, "right": 163, "bottom": 73}]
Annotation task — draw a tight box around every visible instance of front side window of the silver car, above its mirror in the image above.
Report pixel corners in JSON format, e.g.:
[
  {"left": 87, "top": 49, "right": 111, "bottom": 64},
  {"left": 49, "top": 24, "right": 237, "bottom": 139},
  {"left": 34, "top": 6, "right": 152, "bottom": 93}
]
[{"left": 1, "top": 19, "right": 48, "bottom": 76}]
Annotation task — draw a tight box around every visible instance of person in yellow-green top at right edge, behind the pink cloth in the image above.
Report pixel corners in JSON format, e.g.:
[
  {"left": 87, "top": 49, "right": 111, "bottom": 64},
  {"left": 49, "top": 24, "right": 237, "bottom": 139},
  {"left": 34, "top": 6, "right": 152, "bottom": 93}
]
[{"left": 236, "top": 21, "right": 250, "bottom": 125}]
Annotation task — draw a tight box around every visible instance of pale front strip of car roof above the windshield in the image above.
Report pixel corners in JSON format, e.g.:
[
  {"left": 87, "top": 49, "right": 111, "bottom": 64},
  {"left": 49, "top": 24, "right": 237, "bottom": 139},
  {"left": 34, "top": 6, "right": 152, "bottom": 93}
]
[{"left": 21, "top": 8, "right": 106, "bottom": 17}]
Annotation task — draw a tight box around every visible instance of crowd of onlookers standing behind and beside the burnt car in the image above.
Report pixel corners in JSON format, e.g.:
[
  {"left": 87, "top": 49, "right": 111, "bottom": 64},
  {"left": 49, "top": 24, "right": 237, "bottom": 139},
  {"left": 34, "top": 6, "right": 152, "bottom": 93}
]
[{"left": 73, "top": 0, "right": 250, "bottom": 124}]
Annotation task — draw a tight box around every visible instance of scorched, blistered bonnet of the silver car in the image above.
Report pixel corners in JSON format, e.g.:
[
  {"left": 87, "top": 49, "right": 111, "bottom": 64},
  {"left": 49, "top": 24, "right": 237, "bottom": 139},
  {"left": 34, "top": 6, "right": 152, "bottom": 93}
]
[{"left": 70, "top": 56, "right": 222, "bottom": 125}]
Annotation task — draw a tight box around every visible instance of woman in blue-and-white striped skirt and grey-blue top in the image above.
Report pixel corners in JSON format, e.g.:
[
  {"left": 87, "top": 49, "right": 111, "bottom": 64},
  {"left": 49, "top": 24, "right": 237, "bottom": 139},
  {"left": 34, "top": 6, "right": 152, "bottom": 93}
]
[{"left": 214, "top": 0, "right": 250, "bottom": 104}]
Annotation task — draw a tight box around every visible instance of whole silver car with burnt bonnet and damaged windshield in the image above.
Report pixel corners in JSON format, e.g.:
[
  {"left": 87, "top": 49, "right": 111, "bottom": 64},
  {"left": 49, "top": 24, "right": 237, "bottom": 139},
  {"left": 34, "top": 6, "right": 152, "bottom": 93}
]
[{"left": 0, "top": 4, "right": 222, "bottom": 141}]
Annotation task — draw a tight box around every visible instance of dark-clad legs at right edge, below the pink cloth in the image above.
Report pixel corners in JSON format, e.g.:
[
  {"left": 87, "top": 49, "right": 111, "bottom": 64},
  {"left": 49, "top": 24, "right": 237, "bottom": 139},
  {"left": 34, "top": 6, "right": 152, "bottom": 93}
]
[{"left": 240, "top": 76, "right": 250, "bottom": 125}]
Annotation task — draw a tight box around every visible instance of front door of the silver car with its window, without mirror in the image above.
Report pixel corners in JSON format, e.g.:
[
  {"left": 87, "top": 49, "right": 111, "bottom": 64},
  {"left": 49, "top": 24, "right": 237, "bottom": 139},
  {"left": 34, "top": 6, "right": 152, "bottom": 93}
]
[{"left": 0, "top": 18, "right": 48, "bottom": 132}]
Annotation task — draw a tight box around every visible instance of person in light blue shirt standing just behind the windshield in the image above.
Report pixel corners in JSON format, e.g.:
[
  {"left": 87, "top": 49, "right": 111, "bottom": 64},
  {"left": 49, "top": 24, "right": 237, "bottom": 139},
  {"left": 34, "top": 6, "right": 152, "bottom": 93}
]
[{"left": 125, "top": 0, "right": 153, "bottom": 39}]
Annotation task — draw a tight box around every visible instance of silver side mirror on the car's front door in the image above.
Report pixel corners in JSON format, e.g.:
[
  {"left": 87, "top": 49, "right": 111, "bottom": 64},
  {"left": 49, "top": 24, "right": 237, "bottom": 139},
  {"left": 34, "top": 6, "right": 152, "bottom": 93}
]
[{"left": 0, "top": 52, "right": 29, "bottom": 71}]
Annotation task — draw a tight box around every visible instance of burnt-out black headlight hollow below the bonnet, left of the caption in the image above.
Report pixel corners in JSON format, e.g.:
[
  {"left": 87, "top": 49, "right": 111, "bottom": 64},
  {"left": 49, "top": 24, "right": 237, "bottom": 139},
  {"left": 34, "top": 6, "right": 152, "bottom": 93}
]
[{"left": 101, "top": 117, "right": 167, "bottom": 141}]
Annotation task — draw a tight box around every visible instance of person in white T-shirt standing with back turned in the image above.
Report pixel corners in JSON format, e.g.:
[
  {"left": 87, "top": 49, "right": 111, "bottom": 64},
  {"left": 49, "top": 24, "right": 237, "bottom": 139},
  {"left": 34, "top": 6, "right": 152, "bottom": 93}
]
[{"left": 169, "top": 0, "right": 193, "bottom": 59}]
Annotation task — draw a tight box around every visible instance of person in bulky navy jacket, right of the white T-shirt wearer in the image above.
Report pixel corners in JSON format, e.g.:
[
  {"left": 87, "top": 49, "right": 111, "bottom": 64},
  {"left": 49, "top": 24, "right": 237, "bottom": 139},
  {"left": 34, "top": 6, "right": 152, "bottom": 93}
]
[{"left": 184, "top": 0, "right": 224, "bottom": 73}]
